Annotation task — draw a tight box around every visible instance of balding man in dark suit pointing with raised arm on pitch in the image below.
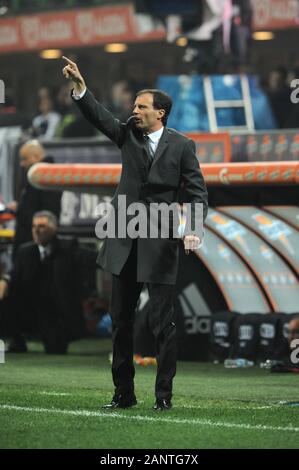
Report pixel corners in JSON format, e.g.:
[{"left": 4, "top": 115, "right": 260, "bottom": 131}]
[{"left": 63, "top": 54, "right": 207, "bottom": 410}]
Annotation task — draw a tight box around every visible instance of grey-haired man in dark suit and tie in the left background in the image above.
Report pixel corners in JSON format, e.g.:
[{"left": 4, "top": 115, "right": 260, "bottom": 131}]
[{"left": 0, "top": 211, "right": 96, "bottom": 354}]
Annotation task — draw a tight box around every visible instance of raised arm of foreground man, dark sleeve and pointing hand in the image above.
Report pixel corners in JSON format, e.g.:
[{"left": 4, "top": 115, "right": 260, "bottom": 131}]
[{"left": 62, "top": 56, "right": 125, "bottom": 147}]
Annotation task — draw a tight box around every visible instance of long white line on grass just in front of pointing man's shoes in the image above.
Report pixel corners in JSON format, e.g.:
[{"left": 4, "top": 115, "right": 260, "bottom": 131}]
[{"left": 0, "top": 404, "right": 299, "bottom": 432}]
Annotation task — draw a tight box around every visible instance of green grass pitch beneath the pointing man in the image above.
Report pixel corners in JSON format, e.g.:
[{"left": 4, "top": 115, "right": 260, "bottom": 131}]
[{"left": 0, "top": 340, "right": 299, "bottom": 449}]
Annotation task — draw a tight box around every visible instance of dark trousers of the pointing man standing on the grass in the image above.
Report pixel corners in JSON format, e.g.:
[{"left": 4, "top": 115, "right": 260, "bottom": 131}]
[{"left": 110, "top": 241, "right": 177, "bottom": 399}]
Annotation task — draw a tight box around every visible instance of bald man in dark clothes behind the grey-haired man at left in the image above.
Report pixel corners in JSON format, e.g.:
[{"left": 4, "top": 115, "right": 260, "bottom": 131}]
[{"left": 7, "top": 139, "right": 61, "bottom": 259}]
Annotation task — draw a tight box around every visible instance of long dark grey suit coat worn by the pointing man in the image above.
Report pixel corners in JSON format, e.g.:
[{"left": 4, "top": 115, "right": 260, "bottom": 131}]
[{"left": 75, "top": 90, "right": 207, "bottom": 284}]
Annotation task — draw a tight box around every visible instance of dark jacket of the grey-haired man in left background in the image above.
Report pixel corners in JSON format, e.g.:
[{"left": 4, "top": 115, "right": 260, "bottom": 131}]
[{"left": 9, "top": 238, "right": 96, "bottom": 341}]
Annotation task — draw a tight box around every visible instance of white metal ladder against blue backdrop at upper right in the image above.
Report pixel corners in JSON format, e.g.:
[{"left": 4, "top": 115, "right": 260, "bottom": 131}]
[{"left": 203, "top": 74, "right": 254, "bottom": 132}]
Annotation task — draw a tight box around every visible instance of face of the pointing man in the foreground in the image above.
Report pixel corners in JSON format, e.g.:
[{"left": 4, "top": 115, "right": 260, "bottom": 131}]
[{"left": 133, "top": 93, "right": 165, "bottom": 133}]
